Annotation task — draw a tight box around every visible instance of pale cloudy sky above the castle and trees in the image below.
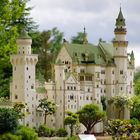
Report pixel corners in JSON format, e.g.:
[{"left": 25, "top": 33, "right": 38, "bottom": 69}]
[{"left": 28, "top": 0, "right": 140, "bottom": 67}]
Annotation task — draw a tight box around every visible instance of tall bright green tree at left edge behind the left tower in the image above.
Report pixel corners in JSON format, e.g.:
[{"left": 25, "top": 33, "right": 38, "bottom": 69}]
[{"left": 0, "top": 0, "right": 36, "bottom": 97}]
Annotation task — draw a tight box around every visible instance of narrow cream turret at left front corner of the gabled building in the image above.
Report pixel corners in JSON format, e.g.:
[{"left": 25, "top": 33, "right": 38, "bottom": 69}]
[{"left": 54, "top": 60, "right": 65, "bottom": 129}]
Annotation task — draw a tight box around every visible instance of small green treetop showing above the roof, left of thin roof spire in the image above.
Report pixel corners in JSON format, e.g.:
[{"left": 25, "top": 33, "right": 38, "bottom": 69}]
[{"left": 71, "top": 32, "right": 85, "bottom": 44}]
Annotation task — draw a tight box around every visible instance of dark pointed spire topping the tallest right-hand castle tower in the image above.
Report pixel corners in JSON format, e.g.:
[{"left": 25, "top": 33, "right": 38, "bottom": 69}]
[{"left": 116, "top": 6, "right": 125, "bottom": 26}]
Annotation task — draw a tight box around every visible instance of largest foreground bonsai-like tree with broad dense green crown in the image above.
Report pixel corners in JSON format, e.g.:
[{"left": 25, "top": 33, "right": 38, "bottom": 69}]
[{"left": 77, "top": 104, "right": 106, "bottom": 134}]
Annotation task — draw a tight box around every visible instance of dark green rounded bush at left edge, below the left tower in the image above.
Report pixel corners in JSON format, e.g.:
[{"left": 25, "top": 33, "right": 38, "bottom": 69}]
[{"left": 0, "top": 108, "right": 18, "bottom": 134}]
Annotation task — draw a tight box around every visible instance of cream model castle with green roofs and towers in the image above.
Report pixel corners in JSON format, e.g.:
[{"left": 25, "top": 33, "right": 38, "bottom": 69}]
[{"left": 10, "top": 8, "right": 135, "bottom": 132}]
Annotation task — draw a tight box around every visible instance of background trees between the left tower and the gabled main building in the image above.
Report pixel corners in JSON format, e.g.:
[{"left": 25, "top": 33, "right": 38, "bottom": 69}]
[{"left": 32, "top": 27, "right": 63, "bottom": 81}]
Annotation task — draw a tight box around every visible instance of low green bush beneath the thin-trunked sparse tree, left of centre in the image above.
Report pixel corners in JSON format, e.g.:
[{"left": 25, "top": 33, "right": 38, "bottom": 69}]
[{"left": 38, "top": 125, "right": 55, "bottom": 137}]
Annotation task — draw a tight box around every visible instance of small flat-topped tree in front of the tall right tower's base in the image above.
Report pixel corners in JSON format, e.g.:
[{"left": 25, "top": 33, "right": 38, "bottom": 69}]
[{"left": 108, "top": 96, "right": 132, "bottom": 119}]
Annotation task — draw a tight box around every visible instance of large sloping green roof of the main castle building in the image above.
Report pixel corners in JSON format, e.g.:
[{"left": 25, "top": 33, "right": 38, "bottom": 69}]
[{"left": 64, "top": 42, "right": 114, "bottom": 65}]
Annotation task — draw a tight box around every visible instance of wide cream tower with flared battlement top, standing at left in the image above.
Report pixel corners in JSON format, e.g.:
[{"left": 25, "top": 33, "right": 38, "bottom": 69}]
[{"left": 10, "top": 30, "right": 38, "bottom": 126}]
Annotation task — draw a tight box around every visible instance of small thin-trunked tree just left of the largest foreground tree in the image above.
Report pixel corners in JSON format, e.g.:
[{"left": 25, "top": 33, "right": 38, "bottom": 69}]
[{"left": 64, "top": 112, "right": 79, "bottom": 137}]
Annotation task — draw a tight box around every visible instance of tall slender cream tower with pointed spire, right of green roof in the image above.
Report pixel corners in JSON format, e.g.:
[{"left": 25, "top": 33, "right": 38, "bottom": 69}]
[{"left": 113, "top": 8, "right": 128, "bottom": 95}]
